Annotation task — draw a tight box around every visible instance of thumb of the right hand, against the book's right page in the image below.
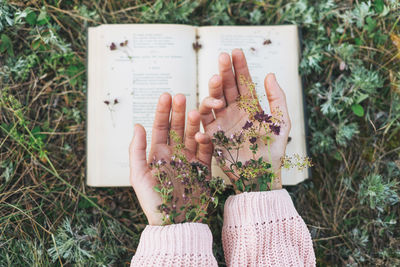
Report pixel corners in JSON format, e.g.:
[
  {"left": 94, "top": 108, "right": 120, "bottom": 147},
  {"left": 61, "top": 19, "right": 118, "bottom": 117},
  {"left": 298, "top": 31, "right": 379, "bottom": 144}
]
[{"left": 264, "top": 73, "right": 291, "bottom": 134}]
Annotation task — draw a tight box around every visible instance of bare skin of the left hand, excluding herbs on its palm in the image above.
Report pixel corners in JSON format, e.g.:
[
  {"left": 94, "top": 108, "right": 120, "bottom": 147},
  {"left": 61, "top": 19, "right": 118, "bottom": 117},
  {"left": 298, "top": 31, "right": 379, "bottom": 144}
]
[{"left": 129, "top": 93, "right": 212, "bottom": 225}]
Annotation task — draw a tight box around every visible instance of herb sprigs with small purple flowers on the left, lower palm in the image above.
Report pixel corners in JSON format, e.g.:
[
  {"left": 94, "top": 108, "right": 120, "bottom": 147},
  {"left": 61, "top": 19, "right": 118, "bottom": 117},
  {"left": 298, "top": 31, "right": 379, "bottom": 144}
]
[{"left": 149, "top": 131, "right": 225, "bottom": 225}]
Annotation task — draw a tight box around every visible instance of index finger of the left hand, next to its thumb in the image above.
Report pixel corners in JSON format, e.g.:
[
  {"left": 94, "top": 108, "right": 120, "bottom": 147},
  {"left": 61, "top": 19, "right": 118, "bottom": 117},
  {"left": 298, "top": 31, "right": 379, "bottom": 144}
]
[{"left": 151, "top": 93, "right": 171, "bottom": 147}]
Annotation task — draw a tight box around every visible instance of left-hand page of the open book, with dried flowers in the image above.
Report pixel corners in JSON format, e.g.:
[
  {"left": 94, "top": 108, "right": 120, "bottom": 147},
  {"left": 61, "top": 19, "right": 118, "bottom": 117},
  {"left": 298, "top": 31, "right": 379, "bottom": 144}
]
[{"left": 87, "top": 24, "right": 197, "bottom": 186}]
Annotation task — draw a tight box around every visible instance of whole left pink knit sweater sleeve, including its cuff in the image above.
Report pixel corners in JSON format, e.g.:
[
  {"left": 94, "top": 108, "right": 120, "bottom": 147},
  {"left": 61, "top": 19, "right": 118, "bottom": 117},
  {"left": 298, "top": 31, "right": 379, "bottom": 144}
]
[{"left": 131, "top": 223, "right": 218, "bottom": 267}]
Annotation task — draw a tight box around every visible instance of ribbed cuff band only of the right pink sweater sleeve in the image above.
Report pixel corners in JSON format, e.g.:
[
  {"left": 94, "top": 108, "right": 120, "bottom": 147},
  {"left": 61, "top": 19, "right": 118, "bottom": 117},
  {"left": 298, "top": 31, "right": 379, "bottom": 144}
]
[{"left": 224, "top": 189, "right": 299, "bottom": 226}]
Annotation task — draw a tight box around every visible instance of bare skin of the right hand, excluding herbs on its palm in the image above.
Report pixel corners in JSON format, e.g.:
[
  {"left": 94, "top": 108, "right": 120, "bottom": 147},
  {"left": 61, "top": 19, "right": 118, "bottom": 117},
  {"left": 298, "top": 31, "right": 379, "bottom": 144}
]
[{"left": 200, "top": 49, "right": 291, "bottom": 189}]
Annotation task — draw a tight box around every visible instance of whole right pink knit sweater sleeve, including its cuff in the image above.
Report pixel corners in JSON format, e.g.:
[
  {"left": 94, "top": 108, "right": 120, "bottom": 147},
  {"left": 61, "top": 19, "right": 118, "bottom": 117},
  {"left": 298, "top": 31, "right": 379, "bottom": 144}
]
[{"left": 222, "top": 189, "right": 315, "bottom": 266}]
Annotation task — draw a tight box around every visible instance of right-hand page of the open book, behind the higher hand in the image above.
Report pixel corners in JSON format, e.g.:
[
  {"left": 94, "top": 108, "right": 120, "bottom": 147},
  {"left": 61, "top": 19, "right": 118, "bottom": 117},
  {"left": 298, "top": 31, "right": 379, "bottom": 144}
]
[{"left": 198, "top": 25, "right": 308, "bottom": 185}]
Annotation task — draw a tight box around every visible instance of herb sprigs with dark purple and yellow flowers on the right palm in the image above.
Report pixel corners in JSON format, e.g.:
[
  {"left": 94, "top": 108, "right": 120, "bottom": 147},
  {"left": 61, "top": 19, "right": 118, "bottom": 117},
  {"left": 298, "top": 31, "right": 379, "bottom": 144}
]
[{"left": 212, "top": 76, "right": 312, "bottom": 193}]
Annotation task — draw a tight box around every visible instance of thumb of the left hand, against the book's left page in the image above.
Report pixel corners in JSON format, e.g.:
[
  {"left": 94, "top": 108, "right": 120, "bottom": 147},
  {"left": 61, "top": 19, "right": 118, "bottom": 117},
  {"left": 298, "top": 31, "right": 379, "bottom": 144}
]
[{"left": 129, "top": 124, "right": 148, "bottom": 185}]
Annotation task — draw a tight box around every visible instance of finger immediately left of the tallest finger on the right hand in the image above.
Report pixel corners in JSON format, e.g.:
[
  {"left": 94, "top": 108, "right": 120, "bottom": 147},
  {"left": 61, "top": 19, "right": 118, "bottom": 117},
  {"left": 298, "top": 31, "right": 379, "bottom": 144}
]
[{"left": 218, "top": 53, "right": 239, "bottom": 105}]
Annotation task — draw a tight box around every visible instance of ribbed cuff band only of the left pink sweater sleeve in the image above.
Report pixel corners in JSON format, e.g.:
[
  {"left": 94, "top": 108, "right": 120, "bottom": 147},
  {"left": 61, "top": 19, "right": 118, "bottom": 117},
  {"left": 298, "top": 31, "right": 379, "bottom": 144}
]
[{"left": 135, "top": 223, "right": 213, "bottom": 257}]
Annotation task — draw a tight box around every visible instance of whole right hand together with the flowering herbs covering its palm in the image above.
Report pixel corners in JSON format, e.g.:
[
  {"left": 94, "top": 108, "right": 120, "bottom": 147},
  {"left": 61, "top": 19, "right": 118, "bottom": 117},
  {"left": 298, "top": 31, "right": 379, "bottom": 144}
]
[{"left": 200, "top": 49, "right": 312, "bottom": 193}]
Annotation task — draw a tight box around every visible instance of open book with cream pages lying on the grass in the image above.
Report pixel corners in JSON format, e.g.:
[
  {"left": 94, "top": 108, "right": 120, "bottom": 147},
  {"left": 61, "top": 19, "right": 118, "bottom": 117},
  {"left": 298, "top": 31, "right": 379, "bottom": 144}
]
[{"left": 87, "top": 24, "right": 308, "bottom": 186}]
